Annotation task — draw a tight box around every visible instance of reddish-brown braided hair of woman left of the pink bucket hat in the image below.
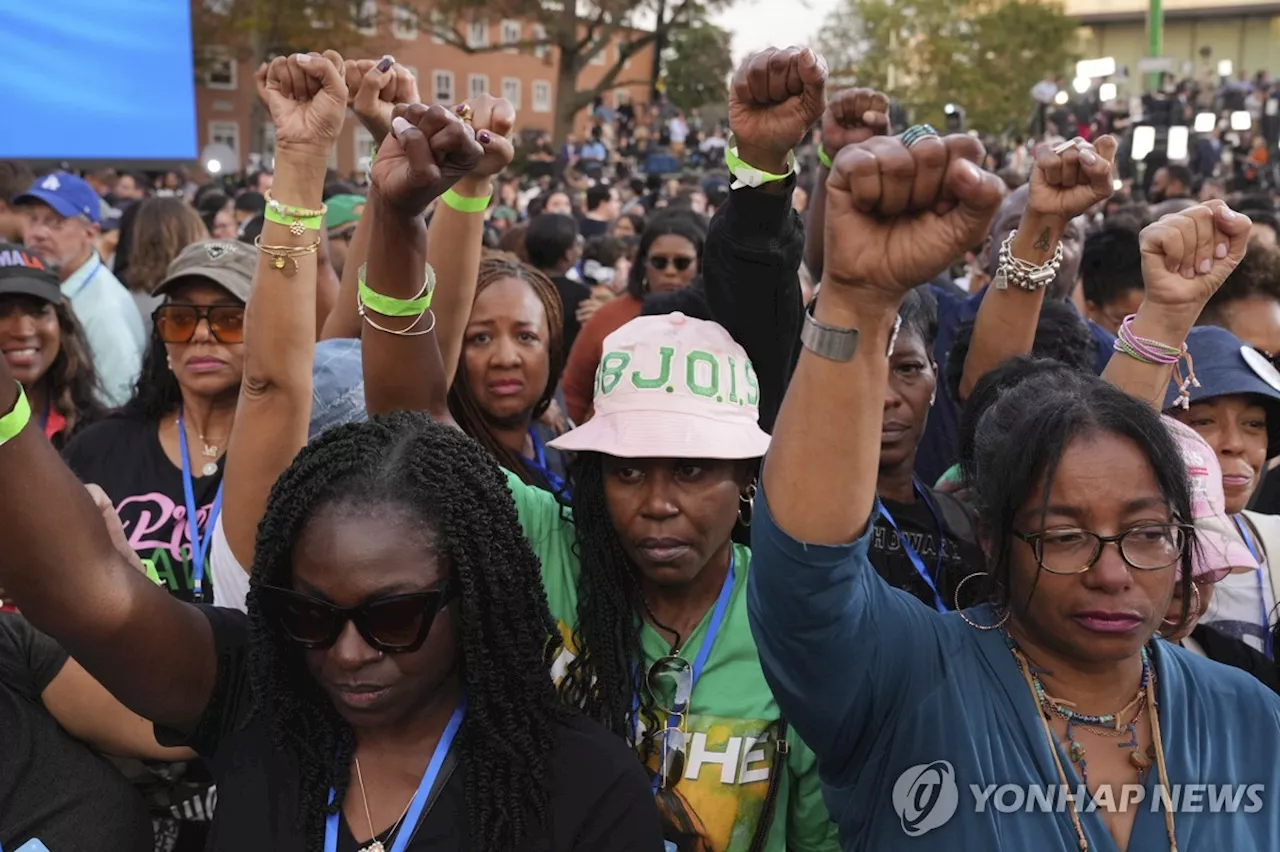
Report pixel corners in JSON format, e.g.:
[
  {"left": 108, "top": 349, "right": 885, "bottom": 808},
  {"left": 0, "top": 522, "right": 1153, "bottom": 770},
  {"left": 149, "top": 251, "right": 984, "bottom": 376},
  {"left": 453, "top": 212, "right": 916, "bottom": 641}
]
[{"left": 449, "top": 253, "right": 564, "bottom": 483}]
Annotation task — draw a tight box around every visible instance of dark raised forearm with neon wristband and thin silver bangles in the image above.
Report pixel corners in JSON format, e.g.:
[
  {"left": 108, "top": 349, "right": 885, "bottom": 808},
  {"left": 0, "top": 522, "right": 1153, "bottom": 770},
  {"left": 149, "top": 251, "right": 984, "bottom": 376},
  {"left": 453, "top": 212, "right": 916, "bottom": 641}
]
[{"left": 361, "top": 189, "right": 449, "bottom": 420}]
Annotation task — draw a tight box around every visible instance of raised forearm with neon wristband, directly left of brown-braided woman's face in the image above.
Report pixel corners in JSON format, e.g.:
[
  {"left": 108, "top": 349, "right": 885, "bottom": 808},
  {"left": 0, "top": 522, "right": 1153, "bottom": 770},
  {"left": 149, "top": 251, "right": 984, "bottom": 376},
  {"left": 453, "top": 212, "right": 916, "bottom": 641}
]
[{"left": 426, "top": 178, "right": 493, "bottom": 384}]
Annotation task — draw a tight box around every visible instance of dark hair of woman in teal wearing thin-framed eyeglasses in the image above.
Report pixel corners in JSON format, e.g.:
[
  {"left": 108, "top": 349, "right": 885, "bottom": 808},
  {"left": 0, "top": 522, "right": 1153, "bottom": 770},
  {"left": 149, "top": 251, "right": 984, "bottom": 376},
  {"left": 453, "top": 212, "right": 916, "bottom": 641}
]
[{"left": 966, "top": 362, "right": 1196, "bottom": 620}]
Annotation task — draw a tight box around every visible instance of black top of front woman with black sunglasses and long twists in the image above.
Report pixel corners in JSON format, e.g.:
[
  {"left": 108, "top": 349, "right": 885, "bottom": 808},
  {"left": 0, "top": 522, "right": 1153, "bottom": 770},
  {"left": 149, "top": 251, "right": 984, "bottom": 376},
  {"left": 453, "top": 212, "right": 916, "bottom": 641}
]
[{"left": 156, "top": 606, "right": 663, "bottom": 852}]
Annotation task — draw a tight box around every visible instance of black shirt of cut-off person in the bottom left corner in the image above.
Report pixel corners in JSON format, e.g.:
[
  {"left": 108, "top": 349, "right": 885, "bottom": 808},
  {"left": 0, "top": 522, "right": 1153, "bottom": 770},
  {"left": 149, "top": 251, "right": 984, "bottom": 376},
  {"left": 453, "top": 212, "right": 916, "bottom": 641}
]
[{"left": 0, "top": 613, "right": 152, "bottom": 852}]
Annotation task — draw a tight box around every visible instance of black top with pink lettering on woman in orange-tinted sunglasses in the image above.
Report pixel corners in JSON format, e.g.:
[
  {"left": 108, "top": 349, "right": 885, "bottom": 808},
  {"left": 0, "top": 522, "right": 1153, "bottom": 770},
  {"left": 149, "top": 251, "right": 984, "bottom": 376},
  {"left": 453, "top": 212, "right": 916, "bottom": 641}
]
[{"left": 63, "top": 416, "right": 223, "bottom": 601}]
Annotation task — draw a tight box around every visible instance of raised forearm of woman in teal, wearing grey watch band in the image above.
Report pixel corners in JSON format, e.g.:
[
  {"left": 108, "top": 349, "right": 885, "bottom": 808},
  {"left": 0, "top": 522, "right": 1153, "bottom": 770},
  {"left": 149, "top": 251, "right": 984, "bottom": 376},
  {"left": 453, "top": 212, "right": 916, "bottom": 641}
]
[{"left": 764, "top": 285, "right": 897, "bottom": 544}]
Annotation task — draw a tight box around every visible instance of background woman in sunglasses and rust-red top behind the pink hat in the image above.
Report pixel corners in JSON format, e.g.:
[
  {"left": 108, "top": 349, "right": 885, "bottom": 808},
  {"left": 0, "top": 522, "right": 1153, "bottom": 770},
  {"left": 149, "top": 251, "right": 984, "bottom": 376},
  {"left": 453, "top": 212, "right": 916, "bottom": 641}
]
[{"left": 563, "top": 212, "right": 707, "bottom": 423}]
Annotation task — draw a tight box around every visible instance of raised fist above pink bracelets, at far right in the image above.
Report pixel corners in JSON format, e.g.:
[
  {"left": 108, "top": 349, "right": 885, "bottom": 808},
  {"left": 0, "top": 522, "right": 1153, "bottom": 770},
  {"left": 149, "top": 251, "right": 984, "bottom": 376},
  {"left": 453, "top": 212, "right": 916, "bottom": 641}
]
[{"left": 1138, "top": 201, "right": 1253, "bottom": 325}]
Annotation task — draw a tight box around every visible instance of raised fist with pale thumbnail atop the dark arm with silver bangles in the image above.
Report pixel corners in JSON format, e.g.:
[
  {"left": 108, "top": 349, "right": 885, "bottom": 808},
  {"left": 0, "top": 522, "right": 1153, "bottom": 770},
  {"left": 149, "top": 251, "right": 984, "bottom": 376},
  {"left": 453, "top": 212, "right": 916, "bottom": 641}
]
[{"left": 371, "top": 104, "right": 493, "bottom": 216}]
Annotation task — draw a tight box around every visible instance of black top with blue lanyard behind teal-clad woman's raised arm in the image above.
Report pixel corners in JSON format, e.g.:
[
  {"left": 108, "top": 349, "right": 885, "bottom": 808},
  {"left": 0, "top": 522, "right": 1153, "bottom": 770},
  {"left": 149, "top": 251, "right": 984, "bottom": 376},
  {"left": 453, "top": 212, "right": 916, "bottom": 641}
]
[{"left": 868, "top": 486, "right": 989, "bottom": 609}]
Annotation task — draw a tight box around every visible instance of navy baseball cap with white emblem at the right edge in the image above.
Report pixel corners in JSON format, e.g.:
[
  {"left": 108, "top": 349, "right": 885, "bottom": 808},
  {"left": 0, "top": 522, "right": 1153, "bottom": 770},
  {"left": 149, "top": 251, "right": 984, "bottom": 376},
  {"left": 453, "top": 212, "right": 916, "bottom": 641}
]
[{"left": 1165, "top": 325, "right": 1280, "bottom": 458}]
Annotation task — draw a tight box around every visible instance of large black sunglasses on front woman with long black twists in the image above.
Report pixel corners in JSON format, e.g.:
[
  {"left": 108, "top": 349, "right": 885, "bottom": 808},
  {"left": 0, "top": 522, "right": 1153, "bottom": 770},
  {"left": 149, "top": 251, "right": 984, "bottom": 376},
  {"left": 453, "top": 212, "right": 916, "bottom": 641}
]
[{"left": 256, "top": 580, "right": 457, "bottom": 654}]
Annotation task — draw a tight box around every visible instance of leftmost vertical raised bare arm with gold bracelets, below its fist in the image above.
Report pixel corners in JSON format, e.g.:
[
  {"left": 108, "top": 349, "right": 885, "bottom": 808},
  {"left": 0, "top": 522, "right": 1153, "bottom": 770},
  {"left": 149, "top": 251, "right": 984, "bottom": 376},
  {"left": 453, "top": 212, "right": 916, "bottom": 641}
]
[{"left": 223, "top": 150, "right": 332, "bottom": 569}]
